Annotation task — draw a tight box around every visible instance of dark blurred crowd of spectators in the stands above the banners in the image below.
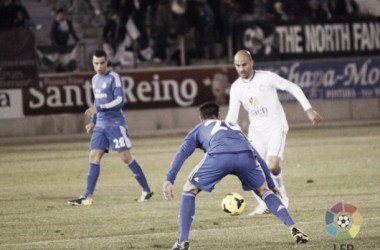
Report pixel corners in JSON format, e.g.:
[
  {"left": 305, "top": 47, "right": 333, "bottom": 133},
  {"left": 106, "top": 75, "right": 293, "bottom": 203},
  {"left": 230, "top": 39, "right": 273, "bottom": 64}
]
[{"left": 0, "top": 0, "right": 380, "bottom": 70}]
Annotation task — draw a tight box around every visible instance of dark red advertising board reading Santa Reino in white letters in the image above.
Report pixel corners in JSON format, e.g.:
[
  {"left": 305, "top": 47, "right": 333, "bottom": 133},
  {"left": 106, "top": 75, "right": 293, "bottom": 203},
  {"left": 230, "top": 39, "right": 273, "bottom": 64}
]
[{"left": 23, "top": 66, "right": 237, "bottom": 116}]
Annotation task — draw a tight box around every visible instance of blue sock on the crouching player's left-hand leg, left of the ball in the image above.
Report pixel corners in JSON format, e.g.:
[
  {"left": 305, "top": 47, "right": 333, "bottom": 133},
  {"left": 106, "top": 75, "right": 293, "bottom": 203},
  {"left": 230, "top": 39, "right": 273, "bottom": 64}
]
[{"left": 178, "top": 191, "right": 195, "bottom": 243}]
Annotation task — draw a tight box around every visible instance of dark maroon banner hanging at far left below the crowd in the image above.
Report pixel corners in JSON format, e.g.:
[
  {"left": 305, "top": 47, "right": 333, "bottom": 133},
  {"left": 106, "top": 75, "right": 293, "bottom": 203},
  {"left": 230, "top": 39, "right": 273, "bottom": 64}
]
[{"left": 0, "top": 27, "right": 38, "bottom": 89}]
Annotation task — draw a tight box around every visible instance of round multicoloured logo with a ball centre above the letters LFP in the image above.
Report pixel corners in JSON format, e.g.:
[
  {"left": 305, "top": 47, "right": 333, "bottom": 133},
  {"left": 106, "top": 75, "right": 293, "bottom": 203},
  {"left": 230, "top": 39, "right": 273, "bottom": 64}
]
[{"left": 325, "top": 202, "right": 363, "bottom": 240}]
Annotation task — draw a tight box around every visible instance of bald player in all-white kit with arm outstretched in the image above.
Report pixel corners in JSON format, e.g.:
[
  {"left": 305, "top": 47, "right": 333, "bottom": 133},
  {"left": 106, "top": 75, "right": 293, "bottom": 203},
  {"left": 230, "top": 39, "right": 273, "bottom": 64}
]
[{"left": 225, "top": 50, "right": 322, "bottom": 215}]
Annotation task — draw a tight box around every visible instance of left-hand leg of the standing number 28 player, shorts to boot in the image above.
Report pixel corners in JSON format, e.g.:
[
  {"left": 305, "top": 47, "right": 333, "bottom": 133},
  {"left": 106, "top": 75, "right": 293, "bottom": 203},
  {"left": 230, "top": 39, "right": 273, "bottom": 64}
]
[{"left": 68, "top": 127, "right": 109, "bottom": 205}]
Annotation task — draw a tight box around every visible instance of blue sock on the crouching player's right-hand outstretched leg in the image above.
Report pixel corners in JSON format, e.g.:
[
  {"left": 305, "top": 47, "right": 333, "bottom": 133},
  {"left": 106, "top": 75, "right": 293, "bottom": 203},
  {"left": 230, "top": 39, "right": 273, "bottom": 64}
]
[{"left": 262, "top": 191, "right": 294, "bottom": 227}]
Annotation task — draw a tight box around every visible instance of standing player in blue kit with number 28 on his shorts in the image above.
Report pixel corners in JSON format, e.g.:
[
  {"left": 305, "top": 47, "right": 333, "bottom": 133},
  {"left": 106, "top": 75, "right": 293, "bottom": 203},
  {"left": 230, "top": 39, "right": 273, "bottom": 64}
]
[{"left": 68, "top": 50, "right": 153, "bottom": 205}]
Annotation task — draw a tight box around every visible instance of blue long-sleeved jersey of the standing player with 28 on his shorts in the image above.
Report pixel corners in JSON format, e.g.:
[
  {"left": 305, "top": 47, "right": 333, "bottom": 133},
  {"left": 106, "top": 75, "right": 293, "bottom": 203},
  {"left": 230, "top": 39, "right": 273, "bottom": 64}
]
[{"left": 91, "top": 70, "right": 127, "bottom": 126}]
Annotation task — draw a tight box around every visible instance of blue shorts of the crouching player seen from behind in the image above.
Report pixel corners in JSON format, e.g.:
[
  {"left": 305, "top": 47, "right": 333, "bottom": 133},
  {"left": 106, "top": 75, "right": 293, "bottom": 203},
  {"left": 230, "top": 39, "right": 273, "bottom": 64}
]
[{"left": 188, "top": 152, "right": 266, "bottom": 192}]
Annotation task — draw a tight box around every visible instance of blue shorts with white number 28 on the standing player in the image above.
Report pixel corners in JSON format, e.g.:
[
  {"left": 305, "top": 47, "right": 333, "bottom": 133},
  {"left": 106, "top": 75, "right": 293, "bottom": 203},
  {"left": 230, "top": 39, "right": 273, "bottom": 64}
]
[{"left": 90, "top": 126, "right": 132, "bottom": 153}]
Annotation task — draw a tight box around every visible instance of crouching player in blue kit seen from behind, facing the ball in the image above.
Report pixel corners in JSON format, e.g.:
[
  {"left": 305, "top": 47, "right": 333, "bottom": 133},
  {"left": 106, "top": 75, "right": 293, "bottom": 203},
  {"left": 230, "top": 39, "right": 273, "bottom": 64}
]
[{"left": 163, "top": 103, "right": 309, "bottom": 250}]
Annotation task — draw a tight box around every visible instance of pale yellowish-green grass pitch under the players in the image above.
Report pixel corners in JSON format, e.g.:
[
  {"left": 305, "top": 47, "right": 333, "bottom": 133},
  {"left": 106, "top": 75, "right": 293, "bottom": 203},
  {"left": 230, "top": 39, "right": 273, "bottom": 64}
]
[{"left": 0, "top": 125, "right": 380, "bottom": 250}]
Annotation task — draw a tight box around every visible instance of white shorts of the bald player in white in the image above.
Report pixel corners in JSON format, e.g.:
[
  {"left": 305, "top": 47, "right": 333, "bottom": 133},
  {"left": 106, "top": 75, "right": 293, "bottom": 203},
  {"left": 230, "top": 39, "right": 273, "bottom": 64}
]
[{"left": 248, "top": 129, "right": 288, "bottom": 160}]
